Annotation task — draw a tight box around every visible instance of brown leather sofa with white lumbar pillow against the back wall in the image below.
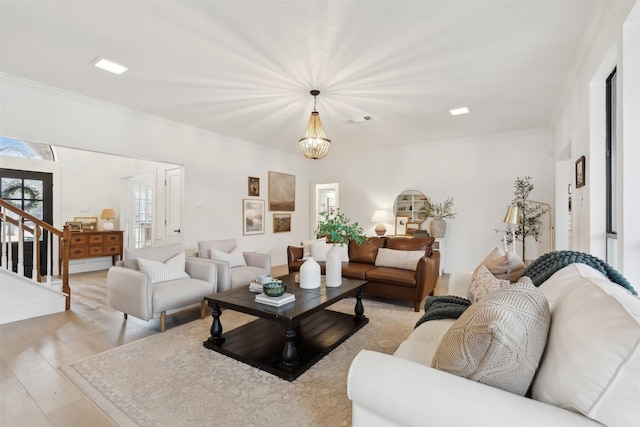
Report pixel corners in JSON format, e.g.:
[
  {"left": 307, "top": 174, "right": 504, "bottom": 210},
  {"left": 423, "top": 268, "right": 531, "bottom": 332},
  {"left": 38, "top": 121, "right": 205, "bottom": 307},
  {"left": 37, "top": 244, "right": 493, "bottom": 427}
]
[{"left": 287, "top": 237, "right": 440, "bottom": 311}]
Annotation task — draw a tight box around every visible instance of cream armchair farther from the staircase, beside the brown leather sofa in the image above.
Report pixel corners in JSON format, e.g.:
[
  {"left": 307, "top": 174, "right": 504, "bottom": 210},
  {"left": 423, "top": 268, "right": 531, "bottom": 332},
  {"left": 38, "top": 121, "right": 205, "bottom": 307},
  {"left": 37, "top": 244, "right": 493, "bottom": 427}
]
[{"left": 191, "top": 239, "right": 271, "bottom": 292}]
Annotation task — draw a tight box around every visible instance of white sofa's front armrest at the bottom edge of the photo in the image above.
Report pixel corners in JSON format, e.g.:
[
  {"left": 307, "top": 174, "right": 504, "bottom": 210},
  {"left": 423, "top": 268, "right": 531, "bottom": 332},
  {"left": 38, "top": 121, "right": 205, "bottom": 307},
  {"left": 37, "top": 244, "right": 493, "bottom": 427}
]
[{"left": 347, "top": 350, "right": 601, "bottom": 427}]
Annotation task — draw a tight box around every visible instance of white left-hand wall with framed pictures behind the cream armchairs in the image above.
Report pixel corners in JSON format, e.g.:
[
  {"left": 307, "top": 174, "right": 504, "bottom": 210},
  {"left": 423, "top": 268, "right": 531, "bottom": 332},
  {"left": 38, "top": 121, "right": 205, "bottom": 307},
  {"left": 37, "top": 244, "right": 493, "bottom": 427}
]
[{"left": 0, "top": 75, "right": 313, "bottom": 265}]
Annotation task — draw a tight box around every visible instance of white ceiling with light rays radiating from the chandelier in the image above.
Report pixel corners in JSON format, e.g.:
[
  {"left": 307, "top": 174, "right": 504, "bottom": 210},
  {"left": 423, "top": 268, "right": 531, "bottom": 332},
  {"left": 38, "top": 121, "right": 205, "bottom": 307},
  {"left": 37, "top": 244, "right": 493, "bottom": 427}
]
[{"left": 0, "top": 0, "right": 603, "bottom": 156}]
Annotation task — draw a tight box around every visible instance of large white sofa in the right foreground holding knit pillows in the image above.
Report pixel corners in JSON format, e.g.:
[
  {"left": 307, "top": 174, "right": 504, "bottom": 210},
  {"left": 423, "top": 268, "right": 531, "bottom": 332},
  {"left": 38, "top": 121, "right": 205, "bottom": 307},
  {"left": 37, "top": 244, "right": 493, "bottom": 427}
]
[{"left": 348, "top": 264, "right": 640, "bottom": 427}]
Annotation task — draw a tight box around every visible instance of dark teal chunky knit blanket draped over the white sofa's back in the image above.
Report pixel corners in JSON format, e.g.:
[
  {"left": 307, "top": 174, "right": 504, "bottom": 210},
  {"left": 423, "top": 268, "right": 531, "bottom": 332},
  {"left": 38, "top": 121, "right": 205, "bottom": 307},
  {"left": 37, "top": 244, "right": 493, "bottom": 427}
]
[{"left": 522, "top": 251, "right": 638, "bottom": 295}]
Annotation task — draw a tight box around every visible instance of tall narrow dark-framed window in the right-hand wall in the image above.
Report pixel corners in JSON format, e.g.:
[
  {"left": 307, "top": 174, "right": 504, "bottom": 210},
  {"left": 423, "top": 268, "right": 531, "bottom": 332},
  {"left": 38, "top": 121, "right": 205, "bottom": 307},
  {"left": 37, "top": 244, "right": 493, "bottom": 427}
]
[{"left": 606, "top": 68, "right": 618, "bottom": 267}]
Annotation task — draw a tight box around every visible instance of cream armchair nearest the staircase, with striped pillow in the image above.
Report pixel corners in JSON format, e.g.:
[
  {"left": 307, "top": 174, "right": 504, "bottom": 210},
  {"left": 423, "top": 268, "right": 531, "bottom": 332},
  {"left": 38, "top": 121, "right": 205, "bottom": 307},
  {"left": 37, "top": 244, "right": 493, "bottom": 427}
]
[{"left": 107, "top": 244, "right": 217, "bottom": 332}]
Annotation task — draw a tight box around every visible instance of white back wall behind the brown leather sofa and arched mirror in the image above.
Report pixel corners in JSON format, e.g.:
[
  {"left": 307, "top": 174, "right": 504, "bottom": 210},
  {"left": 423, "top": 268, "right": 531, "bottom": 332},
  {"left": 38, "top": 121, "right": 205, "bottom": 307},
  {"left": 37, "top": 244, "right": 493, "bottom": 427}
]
[{"left": 315, "top": 129, "right": 554, "bottom": 272}]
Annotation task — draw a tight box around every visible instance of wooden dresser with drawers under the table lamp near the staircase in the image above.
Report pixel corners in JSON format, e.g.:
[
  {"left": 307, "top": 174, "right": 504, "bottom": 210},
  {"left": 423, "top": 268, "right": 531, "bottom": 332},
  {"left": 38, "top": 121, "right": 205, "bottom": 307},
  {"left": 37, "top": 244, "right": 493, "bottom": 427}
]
[{"left": 60, "top": 231, "right": 123, "bottom": 264}]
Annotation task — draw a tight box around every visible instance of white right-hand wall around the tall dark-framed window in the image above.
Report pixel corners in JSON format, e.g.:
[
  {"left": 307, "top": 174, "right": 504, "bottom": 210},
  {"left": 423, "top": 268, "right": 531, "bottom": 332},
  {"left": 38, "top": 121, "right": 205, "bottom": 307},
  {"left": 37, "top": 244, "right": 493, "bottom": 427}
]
[{"left": 553, "top": 2, "right": 640, "bottom": 283}]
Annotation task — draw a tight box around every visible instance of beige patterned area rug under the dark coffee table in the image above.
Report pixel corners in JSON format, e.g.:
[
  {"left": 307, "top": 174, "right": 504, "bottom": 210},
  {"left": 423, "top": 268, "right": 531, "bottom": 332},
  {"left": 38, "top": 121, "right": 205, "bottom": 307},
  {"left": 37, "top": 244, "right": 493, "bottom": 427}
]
[{"left": 63, "top": 298, "right": 421, "bottom": 427}]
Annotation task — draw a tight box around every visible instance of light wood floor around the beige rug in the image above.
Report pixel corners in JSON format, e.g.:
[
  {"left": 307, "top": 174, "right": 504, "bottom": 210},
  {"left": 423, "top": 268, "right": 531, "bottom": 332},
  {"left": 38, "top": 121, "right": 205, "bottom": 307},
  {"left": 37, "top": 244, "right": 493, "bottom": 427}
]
[{"left": 0, "top": 266, "right": 446, "bottom": 427}]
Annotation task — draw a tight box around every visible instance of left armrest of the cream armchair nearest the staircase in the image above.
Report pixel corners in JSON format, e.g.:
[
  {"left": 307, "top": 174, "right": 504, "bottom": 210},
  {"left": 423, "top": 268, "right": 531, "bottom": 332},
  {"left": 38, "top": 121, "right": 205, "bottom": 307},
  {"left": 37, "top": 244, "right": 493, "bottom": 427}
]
[{"left": 107, "top": 267, "right": 153, "bottom": 320}]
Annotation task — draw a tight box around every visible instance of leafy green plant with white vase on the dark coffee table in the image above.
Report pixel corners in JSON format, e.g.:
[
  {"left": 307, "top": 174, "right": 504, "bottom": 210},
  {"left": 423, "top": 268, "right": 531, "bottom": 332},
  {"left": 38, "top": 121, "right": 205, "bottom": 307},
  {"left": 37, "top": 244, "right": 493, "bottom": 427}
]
[{"left": 314, "top": 209, "right": 367, "bottom": 287}]
